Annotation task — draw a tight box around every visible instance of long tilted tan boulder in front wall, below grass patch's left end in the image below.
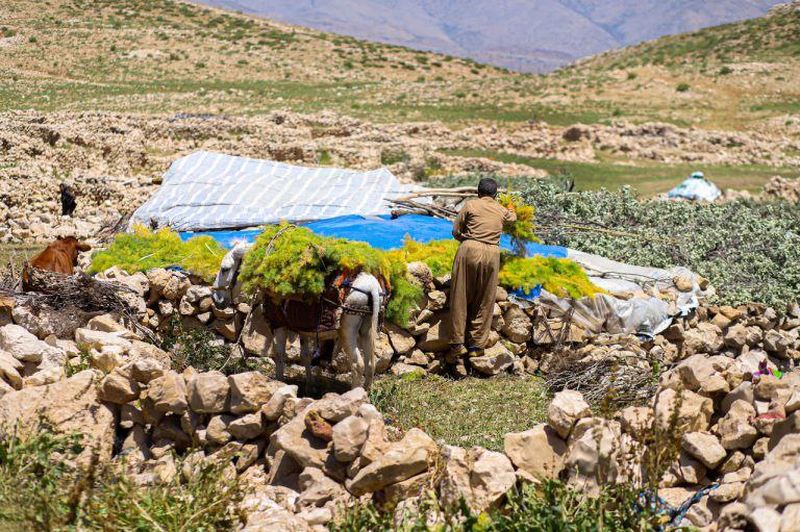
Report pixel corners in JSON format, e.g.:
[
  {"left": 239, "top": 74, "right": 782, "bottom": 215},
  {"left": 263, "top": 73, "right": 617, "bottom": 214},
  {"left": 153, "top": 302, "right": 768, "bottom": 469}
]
[{"left": 346, "top": 428, "right": 438, "bottom": 497}]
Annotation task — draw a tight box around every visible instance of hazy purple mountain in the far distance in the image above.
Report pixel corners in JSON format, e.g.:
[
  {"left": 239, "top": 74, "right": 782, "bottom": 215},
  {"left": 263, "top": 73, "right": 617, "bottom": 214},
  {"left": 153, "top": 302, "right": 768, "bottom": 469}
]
[{"left": 200, "top": 0, "right": 780, "bottom": 72}]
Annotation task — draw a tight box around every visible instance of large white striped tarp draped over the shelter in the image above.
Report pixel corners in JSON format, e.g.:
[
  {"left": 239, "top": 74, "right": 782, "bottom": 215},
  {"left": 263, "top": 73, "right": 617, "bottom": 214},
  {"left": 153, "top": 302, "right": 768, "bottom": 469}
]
[{"left": 130, "top": 151, "right": 416, "bottom": 231}]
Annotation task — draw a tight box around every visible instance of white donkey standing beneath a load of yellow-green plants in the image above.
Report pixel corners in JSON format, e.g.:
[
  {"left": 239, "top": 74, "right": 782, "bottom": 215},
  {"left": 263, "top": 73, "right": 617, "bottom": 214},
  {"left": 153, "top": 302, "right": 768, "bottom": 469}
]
[{"left": 213, "top": 243, "right": 384, "bottom": 389}]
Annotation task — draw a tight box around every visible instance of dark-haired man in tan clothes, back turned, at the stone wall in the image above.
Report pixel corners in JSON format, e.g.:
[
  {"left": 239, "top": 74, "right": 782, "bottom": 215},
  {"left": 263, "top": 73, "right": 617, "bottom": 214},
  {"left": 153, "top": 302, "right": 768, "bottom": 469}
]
[{"left": 450, "top": 178, "right": 517, "bottom": 356}]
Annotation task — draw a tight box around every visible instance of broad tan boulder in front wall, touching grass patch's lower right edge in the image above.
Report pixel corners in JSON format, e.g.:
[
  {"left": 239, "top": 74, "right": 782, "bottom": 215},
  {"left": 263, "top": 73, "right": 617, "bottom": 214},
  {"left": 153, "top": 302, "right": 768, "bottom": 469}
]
[{"left": 504, "top": 423, "right": 567, "bottom": 480}]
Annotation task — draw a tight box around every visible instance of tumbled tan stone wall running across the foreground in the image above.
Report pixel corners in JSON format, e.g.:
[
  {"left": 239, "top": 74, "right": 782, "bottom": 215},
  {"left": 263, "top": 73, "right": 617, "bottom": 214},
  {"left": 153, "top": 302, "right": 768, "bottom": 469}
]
[{"left": 0, "top": 306, "right": 800, "bottom": 531}]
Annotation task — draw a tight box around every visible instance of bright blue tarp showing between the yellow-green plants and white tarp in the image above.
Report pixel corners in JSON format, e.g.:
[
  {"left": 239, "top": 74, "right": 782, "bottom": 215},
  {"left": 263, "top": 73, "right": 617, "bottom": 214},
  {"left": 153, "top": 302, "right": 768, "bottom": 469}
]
[{"left": 181, "top": 214, "right": 567, "bottom": 258}]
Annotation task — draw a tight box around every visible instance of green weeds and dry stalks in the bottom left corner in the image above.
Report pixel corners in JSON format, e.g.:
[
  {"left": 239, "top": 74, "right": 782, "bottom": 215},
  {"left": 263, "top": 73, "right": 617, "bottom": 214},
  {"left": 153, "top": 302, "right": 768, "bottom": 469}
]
[{"left": 0, "top": 428, "right": 241, "bottom": 532}]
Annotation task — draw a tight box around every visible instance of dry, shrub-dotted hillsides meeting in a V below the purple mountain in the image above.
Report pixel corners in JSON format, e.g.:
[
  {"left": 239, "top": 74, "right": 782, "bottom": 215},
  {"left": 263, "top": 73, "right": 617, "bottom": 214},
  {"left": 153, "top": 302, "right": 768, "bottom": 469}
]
[{"left": 0, "top": 0, "right": 800, "bottom": 134}]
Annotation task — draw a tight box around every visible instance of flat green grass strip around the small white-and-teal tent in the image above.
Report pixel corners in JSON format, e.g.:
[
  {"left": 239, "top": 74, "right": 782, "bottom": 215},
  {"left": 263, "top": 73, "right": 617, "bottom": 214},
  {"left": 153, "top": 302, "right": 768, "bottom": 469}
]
[{"left": 440, "top": 150, "right": 800, "bottom": 196}]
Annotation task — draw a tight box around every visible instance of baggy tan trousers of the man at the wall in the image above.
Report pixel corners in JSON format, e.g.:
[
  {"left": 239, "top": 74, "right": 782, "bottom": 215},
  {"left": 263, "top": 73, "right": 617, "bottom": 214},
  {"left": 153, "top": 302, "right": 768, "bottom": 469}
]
[{"left": 450, "top": 240, "right": 500, "bottom": 348}]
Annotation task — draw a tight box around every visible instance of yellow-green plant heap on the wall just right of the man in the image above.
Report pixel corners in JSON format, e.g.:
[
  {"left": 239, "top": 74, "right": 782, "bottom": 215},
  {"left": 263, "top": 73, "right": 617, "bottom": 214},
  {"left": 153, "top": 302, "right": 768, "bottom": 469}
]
[{"left": 500, "top": 257, "right": 603, "bottom": 299}]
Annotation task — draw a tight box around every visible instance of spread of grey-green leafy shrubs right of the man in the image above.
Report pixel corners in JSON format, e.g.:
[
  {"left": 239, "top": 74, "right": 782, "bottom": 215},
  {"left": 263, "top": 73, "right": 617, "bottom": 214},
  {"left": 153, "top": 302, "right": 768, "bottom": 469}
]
[{"left": 523, "top": 180, "right": 800, "bottom": 311}]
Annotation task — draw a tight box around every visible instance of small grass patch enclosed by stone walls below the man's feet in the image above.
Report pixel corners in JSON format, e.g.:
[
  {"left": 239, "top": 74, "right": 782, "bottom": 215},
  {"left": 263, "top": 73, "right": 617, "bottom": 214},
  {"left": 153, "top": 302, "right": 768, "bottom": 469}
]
[{"left": 370, "top": 376, "right": 549, "bottom": 450}]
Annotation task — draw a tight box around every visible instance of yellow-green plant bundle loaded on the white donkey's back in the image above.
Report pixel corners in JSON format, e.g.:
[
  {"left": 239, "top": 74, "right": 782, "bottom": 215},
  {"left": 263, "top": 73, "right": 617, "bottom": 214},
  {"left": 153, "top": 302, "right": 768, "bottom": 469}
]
[{"left": 239, "top": 224, "right": 422, "bottom": 325}]
